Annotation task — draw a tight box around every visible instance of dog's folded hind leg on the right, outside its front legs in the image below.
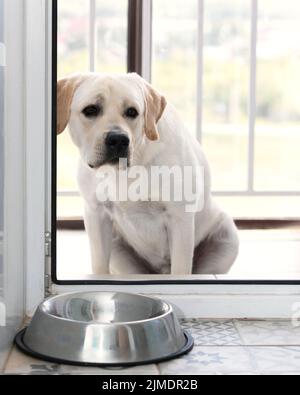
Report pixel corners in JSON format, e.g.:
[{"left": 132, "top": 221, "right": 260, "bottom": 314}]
[{"left": 193, "top": 214, "right": 239, "bottom": 274}]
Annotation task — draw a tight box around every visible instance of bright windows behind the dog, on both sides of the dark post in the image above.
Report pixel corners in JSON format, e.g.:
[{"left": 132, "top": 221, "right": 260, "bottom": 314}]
[{"left": 58, "top": 0, "right": 300, "bottom": 218}]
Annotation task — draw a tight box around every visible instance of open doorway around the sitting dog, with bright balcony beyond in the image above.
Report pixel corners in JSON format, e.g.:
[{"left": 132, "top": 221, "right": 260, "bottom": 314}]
[{"left": 54, "top": 0, "right": 300, "bottom": 282}]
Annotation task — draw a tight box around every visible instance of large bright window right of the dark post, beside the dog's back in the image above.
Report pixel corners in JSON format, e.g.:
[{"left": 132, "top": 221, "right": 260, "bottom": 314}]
[{"left": 152, "top": 0, "right": 300, "bottom": 218}]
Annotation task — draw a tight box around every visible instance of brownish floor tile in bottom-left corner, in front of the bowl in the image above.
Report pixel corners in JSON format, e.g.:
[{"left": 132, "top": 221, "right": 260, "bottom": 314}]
[{"left": 4, "top": 348, "right": 59, "bottom": 375}]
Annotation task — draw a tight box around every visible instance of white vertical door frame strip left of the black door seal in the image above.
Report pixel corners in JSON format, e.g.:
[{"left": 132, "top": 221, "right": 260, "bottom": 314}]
[{"left": 24, "top": 0, "right": 51, "bottom": 312}]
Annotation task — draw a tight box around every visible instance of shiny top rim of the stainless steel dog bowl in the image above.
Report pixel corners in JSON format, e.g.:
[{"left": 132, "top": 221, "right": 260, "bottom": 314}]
[{"left": 39, "top": 291, "right": 174, "bottom": 327}]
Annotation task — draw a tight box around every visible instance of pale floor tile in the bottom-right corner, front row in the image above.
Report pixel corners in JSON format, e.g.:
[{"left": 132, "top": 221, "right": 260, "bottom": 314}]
[{"left": 248, "top": 347, "right": 300, "bottom": 373}]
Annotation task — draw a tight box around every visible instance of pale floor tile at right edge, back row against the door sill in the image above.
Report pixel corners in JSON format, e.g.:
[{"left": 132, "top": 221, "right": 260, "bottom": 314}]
[{"left": 235, "top": 321, "right": 300, "bottom": 346}]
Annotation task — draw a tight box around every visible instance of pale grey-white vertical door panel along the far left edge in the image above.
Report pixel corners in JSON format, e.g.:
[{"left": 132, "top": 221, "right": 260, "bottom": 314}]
[{"left": 0, "top": 0, "right": 26, "bottom": 371}]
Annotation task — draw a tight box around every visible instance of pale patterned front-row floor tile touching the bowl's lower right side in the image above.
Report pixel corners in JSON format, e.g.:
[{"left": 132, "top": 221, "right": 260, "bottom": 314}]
[{"left": 159, "top": 347, "right": 255, "bottom": 375}]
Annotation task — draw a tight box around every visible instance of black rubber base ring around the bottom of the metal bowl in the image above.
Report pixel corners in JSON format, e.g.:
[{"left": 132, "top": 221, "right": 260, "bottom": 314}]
[{"left": 15, "top": 328, "right": 194, "bottom": 368}]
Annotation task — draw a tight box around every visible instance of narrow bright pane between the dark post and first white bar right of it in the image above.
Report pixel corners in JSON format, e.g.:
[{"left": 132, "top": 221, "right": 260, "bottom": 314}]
[{"left": 152, "top": 0, "right": 198, "bottom": 134}]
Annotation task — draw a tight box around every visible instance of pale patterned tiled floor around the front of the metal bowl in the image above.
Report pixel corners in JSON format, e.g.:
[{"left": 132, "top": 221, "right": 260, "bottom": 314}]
[{"left": 4, "top": 319, "right": 300, "bottom": 375}]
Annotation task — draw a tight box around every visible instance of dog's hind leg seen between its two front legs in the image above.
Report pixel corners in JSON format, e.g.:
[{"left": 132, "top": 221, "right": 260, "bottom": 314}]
[{"left": 109, "top": 237, "right": 151, "bottom": 275}]
